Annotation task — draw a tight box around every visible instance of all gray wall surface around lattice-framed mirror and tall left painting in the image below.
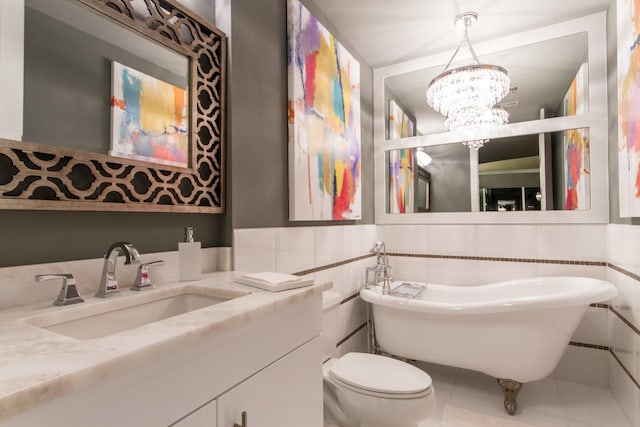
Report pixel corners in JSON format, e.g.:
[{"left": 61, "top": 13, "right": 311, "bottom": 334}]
[{"left": 0, "top": 0, "right": 374, "bottom": 267}]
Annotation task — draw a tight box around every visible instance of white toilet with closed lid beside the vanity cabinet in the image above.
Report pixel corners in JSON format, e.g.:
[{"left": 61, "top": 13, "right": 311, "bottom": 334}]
[{"left": 322, "top": 291, "right": 435, "bottom": 427}]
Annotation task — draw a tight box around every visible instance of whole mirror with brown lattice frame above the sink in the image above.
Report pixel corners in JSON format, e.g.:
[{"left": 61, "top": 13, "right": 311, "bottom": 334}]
[{"left": 0, "top": 0, "right": 226, "bottom": 213}]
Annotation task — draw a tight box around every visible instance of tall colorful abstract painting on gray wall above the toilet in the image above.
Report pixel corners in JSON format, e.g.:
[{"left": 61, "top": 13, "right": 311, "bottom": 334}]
[{"left": 287, "top": 0, "right": 362, "bottom": 221}]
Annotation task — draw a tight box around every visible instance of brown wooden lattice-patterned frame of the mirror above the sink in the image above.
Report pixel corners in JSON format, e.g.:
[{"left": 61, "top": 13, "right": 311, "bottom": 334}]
[{"left": 0, "top": 0, "right": 226, "bottom": 213}]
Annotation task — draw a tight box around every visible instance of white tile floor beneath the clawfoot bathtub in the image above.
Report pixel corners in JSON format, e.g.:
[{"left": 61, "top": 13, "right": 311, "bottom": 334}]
[{"left": 416, "top": 363, "right": 634, "bottom": 427}]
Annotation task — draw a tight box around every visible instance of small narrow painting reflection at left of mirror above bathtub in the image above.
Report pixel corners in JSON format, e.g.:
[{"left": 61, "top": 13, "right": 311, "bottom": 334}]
[{"left": 388, "top": 148, "right": 414, "bottom": 213}]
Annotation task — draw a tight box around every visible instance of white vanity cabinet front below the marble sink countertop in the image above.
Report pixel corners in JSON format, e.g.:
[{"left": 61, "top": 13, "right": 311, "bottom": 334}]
[{"left": 0, "top": 289, "right": 323, "bottom": 427}]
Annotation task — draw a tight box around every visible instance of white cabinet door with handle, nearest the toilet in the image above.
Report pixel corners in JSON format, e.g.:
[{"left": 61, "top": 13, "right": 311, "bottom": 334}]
[{"left": 217, "top": 337, "right": 322, "bottom": 427}]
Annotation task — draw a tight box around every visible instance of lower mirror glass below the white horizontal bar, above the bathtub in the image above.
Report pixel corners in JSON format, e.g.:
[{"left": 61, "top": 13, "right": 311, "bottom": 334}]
[{"left": 387, "top": 128, "right": 591, "bottom": 213}]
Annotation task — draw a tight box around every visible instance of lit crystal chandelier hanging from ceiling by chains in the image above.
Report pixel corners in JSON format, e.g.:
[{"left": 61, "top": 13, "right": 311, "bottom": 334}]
[{"left": 427, "top": 12, "right": 511, "bottom": 150}]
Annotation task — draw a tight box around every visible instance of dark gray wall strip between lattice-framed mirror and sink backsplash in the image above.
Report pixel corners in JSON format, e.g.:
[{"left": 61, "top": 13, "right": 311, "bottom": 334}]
[{"left": 0, "top": 0, "right": 232, "bottom": 267}]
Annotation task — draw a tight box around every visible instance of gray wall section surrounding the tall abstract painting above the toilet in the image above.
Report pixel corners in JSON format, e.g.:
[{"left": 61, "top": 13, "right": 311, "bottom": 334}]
[{"left": 228, "top": 0, "right": 374, "bottom": 228}]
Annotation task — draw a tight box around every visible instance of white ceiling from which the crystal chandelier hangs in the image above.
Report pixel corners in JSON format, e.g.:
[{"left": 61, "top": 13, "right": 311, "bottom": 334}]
[{"left": 312, "top": 0, "right": 612, "bottom": 68}]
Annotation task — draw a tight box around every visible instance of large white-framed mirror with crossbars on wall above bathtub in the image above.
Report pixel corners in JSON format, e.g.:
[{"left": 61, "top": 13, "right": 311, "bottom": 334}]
[{"left": 374, "top": 13, "right": 608, "bottom": 223}]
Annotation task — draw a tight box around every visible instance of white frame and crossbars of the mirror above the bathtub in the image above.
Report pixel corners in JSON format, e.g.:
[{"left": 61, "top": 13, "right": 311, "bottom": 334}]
[{"left": 373, "top": 12, "right": 609, "bottom": 224}]
